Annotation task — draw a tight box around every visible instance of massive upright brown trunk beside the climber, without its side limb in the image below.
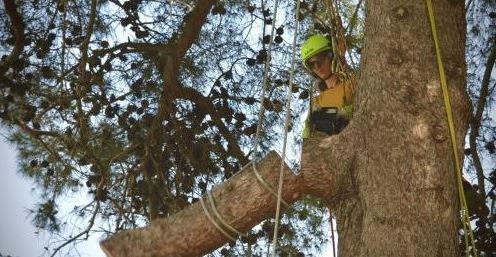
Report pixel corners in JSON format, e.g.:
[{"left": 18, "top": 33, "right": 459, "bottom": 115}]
[{"left": 337, "top": 0, "right": 470, "bottom": 256}]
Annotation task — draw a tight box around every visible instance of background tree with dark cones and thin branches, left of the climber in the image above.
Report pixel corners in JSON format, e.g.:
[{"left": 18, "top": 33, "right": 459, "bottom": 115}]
[{"left": 0, "top": 0, "right": 330, "bottom": 255}]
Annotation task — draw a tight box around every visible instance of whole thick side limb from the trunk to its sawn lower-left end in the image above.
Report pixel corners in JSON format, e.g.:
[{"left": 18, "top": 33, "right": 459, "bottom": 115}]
[{"left": 101, "top": 125, "right": 354, "bottom": 254}]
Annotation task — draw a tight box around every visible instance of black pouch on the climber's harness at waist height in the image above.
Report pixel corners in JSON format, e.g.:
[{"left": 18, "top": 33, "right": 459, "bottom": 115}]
[{"left": 311, "top": 108, "right": 348, "bottom": 135}]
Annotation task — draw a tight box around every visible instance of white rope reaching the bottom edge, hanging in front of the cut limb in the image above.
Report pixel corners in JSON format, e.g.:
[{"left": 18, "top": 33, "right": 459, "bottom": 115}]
[{"left": 272, "top": 1, "right": 300, "bottom": 254}]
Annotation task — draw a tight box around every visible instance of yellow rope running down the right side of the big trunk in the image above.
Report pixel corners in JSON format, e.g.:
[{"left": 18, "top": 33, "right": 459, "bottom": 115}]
[{"left": 426, "top": 0, "right": 478, "bottom": 257}]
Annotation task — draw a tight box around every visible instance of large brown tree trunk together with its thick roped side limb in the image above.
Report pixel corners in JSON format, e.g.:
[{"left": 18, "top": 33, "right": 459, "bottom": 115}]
[{"left": 102, "top": 0, "right": 469, "bottom": 257}]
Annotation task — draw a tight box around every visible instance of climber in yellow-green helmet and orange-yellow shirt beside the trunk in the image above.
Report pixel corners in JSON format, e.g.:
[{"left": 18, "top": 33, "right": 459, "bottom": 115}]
[{"left": 301, "top": 34, "right": 356, "bottom": 138}]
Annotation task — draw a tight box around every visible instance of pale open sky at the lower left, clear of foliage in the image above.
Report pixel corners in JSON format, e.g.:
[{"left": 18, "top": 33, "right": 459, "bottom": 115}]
[{"left": 0, "top": 133, "right": 105, "bottom": 257}]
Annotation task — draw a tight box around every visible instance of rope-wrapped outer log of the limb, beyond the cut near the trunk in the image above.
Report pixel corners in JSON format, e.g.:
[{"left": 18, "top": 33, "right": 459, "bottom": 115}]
[{"left": 101, "top": 152, "right": 320, "bottom": 257}]
